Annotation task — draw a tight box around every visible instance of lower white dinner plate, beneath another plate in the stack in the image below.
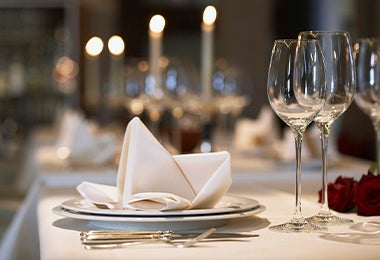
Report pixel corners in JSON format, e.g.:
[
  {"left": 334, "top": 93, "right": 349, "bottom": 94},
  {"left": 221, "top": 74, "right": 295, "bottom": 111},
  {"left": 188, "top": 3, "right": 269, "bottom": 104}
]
[{"left": 53, "top": 205, "right": 265, "bottom": 231}]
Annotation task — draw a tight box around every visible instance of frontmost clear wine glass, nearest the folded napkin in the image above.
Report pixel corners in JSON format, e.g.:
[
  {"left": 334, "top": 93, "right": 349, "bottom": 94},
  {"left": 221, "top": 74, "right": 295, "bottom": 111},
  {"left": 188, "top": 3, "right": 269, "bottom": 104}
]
[{"left": 267, "top": 39, "right": 326, "bottom": 232}]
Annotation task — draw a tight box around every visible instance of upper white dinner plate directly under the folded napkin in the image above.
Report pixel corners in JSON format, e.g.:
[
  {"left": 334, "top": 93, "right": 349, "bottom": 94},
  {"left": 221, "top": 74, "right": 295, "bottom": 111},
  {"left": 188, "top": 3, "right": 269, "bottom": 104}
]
[{"left": 61, "top": 195, "right": 259, "bottom": 217}]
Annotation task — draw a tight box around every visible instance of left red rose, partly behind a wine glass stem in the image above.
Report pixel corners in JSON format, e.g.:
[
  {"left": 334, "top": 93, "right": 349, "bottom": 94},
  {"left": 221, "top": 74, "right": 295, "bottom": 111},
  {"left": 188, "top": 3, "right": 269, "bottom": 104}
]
[{"left": 319, "top": 176, "right": 357, "bottom": 212}]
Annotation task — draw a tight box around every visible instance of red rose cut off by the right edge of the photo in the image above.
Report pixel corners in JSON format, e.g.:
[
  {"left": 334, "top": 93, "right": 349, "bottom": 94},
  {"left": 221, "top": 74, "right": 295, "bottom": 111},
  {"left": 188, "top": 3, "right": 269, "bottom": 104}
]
[{"left": 354, "top": 173, "right": 380, "bottom": 216}]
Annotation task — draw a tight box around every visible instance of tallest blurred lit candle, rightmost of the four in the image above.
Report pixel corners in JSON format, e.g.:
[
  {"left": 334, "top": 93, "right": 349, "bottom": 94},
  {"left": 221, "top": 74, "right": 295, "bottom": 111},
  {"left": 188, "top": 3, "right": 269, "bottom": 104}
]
[{"left": 200, "top": 5, "right": 216, "bottom": 102}]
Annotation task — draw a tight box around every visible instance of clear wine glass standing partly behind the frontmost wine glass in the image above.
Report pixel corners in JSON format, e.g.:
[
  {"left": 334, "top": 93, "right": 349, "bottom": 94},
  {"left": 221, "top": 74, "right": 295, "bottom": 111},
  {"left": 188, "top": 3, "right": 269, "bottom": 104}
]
[{"left": 298, "top": 31, "right": 356, "bottom": 225}]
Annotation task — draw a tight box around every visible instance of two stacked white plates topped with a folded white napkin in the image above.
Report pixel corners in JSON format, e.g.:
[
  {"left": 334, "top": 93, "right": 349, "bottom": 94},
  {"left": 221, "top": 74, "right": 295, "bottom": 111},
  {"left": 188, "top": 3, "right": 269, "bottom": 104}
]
[{"left": 53, "top": 117, "right": 265, "bottom": 231}]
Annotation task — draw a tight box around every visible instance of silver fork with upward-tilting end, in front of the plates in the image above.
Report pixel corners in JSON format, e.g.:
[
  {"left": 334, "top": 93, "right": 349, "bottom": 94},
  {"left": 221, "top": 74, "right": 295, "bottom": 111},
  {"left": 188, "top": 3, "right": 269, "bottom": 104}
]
[{"left": 82, "top": 228, "right": 216, "bottom": 250}]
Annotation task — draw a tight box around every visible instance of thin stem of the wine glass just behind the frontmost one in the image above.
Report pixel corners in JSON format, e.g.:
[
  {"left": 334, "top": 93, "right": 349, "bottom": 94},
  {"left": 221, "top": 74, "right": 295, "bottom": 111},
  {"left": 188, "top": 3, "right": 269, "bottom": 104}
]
[{"left": 320, "top": 125, "right": 329, "bottom": 212}]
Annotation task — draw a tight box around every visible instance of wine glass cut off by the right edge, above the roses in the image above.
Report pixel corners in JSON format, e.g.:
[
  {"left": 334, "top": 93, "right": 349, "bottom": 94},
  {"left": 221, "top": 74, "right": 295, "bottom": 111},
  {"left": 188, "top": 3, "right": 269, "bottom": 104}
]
[{"left": 354, "top": 38, "right": 380, "bottom": 173}]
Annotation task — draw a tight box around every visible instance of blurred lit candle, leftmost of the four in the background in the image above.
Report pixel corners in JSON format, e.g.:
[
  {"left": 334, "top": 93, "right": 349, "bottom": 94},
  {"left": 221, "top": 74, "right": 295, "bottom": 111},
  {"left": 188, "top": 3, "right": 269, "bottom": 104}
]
[{"left": 84, "top": 36, "right": 103, "bottom": 104}]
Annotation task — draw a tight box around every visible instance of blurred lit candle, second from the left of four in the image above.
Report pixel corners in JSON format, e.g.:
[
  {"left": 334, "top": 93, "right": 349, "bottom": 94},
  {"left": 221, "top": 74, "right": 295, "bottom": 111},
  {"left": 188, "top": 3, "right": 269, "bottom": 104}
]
[{"left": 108, "top": 35, "right": 125, "bottom": 96}]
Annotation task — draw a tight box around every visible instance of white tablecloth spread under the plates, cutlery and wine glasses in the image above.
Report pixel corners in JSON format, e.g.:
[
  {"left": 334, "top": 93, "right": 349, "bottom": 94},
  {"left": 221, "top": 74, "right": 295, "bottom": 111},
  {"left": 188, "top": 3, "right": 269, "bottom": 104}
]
[{"left": 0, "top": 153, "right": 380, "bottom": 259}]
